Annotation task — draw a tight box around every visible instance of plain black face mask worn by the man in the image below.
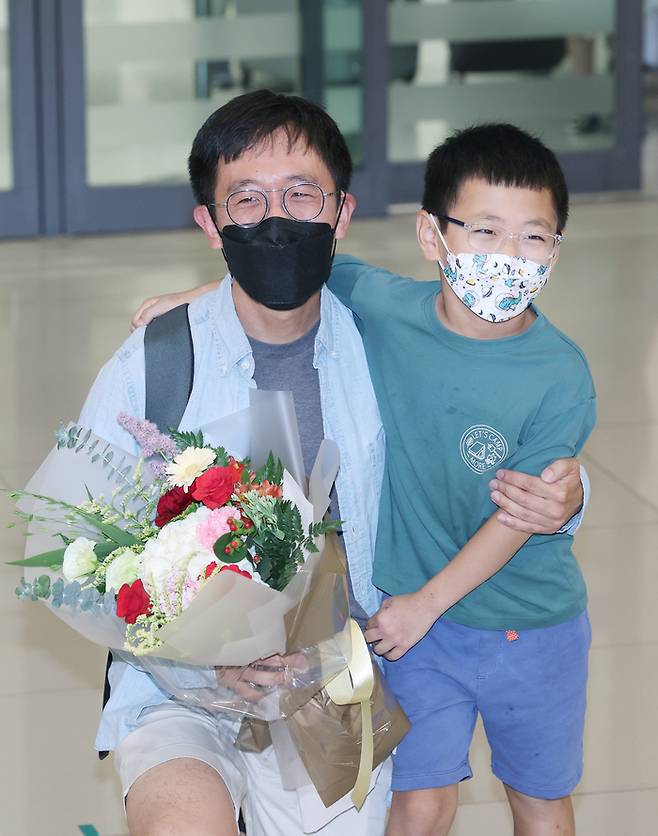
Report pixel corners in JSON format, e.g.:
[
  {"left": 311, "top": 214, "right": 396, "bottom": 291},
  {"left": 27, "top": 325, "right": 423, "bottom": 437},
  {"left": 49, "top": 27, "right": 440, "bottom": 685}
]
[{"left": 221, "top": 216, "right": 335, "bottom": 311}]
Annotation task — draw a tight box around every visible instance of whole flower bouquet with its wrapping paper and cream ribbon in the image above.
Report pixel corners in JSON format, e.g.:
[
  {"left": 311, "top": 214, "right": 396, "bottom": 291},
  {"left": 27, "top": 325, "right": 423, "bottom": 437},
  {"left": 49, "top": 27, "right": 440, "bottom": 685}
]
[{"left": 5, "top": 392, "right": 407, "bottom": 804}]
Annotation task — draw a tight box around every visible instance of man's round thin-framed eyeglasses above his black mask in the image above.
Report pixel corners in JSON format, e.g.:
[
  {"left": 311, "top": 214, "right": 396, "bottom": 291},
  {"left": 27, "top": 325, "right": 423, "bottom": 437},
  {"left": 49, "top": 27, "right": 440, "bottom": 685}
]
[{"left": 209, "top": 183, "right": 340, "bottom": 227}]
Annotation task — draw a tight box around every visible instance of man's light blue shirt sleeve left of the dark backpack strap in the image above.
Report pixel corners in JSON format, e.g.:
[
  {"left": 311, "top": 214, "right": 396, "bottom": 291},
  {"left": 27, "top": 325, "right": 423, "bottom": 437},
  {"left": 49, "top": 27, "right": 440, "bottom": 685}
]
[{"left": 79, "top": 328, "right": 145, "bottom": 453}]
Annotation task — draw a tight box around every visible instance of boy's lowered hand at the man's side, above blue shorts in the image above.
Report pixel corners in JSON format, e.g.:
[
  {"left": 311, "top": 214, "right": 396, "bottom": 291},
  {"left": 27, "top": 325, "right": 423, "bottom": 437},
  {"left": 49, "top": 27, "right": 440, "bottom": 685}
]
[{"left": 364, "top": 589, "right": 440, "bottom": 662}]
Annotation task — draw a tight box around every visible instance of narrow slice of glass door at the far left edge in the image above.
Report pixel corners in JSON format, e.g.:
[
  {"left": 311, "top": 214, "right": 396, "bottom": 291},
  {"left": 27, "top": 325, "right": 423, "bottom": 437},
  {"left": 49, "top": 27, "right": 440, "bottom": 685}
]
[{"left": 0, "top": 0, "right": 39, "bottom": 237}]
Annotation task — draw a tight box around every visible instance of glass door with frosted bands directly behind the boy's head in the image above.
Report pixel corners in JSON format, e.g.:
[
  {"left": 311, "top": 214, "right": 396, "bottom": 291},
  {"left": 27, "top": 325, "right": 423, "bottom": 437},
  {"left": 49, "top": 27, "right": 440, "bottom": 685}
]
[{"left": 388, "top": 0, "right": 642, "bottom": 202}]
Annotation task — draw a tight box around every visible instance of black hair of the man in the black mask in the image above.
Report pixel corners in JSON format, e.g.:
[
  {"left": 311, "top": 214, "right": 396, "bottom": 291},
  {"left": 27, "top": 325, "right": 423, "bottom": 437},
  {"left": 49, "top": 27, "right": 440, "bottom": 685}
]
[{"left": 188, "top": 90, "right": 352, "bottom": 209}]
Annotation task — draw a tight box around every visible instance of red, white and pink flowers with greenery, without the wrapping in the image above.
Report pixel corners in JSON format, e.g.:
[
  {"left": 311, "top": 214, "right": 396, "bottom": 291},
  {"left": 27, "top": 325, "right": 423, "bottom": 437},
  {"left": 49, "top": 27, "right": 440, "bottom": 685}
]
[{"left": 12, "top": 414, "right": 338, "bottom": 655}]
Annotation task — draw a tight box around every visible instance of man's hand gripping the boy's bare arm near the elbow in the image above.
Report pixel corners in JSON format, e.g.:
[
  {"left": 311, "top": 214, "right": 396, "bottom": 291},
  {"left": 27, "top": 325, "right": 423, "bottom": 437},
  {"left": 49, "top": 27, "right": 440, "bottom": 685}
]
[{"left": 489, "top": 459, "right": 583, "bottom": 534}]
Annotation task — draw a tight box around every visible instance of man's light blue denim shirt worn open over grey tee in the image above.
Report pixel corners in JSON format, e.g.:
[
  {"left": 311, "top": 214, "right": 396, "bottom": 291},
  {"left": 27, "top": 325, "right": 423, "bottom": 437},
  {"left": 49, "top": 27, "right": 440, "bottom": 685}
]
[{"left": 80, "top": 280, "right": 384, "bottom": 750}]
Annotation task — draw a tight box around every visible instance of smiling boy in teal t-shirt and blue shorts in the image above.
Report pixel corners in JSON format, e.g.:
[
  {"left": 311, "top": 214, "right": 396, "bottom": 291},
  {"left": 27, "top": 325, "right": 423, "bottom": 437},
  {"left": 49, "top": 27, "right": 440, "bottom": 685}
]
[{"left": 132, "top": 125, "right": 595, "bottom": 836}]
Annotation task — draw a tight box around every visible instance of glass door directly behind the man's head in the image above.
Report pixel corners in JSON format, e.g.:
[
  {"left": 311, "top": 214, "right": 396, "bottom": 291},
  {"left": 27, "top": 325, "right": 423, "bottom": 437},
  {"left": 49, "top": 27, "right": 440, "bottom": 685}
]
[{"left": 56, "top": 0, "right": 385, "bottom": 232}]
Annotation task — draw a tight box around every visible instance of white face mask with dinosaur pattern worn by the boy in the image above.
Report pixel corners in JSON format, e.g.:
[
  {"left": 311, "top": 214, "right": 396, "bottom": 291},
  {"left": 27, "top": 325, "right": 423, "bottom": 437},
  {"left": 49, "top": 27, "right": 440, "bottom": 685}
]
[{"left": 430, "top": 215, "right": 552, "bottom": 322}]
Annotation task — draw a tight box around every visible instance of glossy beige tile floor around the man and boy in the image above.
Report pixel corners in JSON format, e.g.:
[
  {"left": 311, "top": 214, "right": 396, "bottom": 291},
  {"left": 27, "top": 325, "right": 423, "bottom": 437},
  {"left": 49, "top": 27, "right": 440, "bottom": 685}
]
[{"left": 0, "top": 198, "right": 658, "bottom": 836}]
